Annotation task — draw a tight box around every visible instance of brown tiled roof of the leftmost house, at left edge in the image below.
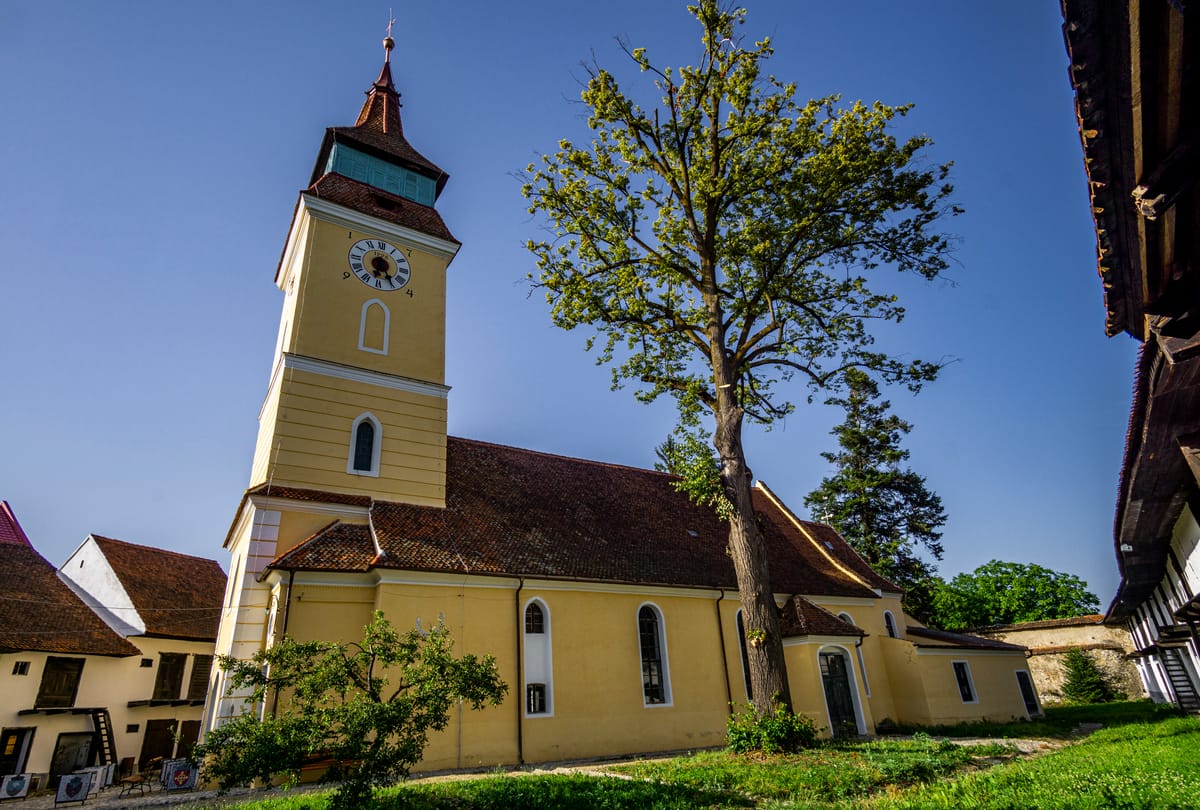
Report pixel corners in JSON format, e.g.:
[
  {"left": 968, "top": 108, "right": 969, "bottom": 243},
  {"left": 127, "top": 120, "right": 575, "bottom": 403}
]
[{"left": 0, "top": 502, "right": 139, "bottom": 655}]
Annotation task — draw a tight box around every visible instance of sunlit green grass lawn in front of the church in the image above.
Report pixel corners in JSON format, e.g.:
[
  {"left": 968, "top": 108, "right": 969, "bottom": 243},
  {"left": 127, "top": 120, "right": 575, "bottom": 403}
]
[{"left": 229, "top": 703, "right": 1200, "bottom": 810}]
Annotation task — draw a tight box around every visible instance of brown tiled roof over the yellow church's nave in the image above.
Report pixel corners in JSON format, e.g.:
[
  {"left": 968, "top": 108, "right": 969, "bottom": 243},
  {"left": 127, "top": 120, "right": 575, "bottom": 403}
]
[{"left": 272, "top": 437, "right": 896, "bottom": 598}]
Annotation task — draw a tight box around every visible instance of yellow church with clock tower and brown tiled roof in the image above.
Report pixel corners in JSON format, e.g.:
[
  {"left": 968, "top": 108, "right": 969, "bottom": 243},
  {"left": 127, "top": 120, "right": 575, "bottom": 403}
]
[{"left": 204, "top": 40, "right": 1039, "bottom": 769}]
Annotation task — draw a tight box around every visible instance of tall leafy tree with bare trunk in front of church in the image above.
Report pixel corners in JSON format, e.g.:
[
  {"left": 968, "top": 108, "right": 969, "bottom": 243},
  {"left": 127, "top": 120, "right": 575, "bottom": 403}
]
[{"left": 523, "top": 0, "right": 956, "bottom": 714}]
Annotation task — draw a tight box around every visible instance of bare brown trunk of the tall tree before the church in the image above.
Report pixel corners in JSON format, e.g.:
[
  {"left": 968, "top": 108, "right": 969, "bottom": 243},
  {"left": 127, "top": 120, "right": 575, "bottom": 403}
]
[{"left": 713, "top": 403, "right": 792, "bottom": 713}]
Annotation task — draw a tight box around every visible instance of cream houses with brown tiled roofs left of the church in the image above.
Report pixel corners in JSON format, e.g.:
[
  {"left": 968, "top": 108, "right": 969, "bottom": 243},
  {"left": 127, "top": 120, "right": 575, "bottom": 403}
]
[{"left": 0, "top": 502, "right": 226, "bottom": 786}]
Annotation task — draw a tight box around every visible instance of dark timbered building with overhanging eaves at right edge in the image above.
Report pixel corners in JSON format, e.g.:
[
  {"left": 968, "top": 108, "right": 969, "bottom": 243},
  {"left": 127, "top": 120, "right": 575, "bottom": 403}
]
[{"left": 1062, "top": 0, "right": 1200, "bottom": 710}]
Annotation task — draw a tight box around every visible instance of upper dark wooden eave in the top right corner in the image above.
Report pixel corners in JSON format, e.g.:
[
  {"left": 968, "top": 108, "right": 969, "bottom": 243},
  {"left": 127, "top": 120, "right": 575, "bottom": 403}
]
[{"left": 1062, "top": 0, "right": 1200, "bottom": 341}]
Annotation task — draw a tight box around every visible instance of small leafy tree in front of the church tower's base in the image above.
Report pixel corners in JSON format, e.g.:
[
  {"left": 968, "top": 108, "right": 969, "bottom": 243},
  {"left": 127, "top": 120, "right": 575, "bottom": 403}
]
[{"left": 192, "top": 611, "right": 508, "bottom": 808}]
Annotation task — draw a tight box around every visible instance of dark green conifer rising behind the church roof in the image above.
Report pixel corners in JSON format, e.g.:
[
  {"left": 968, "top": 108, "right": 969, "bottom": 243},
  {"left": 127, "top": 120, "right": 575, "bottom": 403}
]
[{"left": 804, "top": 368, "right": 946, "bottom": 618}]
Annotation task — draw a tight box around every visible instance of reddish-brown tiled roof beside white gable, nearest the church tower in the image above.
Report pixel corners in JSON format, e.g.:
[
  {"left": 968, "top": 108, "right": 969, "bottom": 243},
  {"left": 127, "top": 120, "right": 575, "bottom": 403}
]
[{"left": 91, "top": 534, "right": 226, "bottom": 641}]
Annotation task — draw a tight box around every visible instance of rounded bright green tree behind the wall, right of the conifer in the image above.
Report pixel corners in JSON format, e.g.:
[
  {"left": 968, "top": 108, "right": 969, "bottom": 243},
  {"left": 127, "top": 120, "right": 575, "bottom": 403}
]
[{"left": 930, "top": 559, "right": 1100, "bottom": 630}]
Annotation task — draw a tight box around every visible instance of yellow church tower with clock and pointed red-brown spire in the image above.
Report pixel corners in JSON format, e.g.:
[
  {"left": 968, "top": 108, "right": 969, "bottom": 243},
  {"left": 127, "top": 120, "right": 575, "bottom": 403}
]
[{"left": 204, "top": 33, "right": 460, "bottom": 730}]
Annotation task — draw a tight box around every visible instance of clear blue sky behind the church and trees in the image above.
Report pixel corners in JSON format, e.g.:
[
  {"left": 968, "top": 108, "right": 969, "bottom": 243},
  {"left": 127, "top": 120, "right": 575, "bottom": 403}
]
[{"left": 0, "top": 0, "right": 1136, "bottom": 607}]
